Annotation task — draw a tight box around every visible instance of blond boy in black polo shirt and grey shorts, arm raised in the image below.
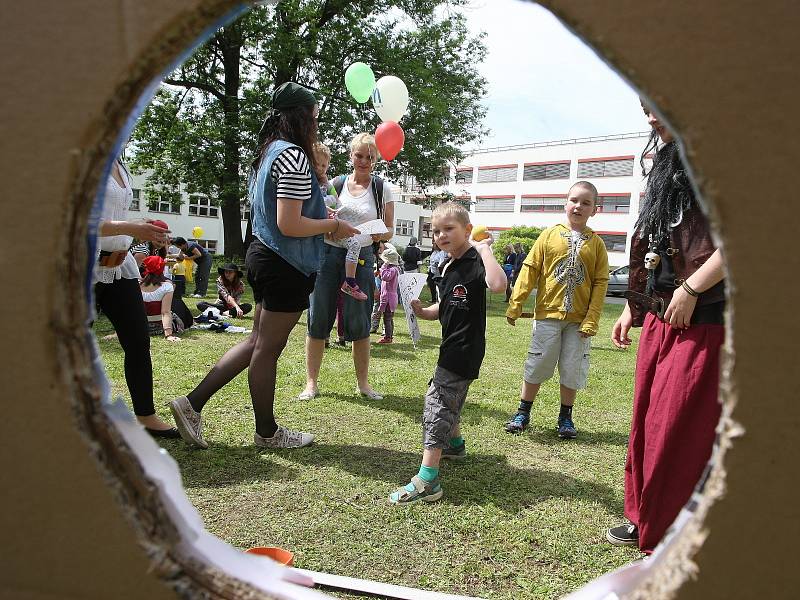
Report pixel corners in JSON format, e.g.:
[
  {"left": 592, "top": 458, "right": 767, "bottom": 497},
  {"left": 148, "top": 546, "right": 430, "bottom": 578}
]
[{"left": 389, "top": 202, "right": 506, "bottom": 504}]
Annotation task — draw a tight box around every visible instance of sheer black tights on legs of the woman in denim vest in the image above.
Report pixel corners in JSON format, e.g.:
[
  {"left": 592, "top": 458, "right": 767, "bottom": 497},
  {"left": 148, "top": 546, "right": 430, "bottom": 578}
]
[{"left": 187, "top": 305, "right": 302, "bottom": 437}]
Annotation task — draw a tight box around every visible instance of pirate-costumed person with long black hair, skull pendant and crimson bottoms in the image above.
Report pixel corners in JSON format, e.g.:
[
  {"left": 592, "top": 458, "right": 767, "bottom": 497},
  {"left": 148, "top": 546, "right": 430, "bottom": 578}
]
[{"left": 606, "top": 106, "right": 725, "bottom": 554}]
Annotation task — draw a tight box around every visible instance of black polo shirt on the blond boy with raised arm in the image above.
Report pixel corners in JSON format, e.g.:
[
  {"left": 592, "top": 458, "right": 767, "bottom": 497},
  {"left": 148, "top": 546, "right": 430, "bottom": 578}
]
[{"left": 435, "top": 248, "right": 486, "bottom": 379}]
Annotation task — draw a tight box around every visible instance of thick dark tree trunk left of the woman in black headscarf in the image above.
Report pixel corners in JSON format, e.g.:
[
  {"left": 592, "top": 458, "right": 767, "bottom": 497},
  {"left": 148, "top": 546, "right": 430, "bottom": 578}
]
[{"left": 219, "top": 24, "right": 244, "bottom": 258}]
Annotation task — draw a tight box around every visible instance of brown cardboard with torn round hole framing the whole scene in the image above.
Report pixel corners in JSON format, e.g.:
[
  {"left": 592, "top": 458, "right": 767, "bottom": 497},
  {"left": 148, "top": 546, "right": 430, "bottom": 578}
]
[{"left": 0, "top": 0, "right": 800, "bottom": 600}]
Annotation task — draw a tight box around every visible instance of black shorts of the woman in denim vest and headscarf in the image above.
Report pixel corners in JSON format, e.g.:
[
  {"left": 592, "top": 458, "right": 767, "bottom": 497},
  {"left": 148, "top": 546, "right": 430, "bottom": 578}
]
[{"left": 245, "top": 239, "right": 317, "bottom": 312}]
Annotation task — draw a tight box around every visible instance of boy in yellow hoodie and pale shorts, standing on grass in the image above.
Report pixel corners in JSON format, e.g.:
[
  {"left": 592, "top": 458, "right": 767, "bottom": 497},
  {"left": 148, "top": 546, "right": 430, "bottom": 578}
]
[{"left": 505, "top": 181, "right": 608, "bottom": 439}]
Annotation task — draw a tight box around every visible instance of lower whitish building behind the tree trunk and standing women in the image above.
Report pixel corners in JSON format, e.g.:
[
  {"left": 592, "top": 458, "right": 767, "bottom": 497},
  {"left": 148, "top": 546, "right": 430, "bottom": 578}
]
[{"left": 129, "top": 174, "right": 431, "bottom": 254}]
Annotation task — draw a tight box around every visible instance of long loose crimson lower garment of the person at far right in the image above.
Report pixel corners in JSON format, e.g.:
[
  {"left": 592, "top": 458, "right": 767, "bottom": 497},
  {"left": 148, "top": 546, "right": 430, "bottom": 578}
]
[{"left": 625, "top": 313, "right": 725, "bottom": 554}]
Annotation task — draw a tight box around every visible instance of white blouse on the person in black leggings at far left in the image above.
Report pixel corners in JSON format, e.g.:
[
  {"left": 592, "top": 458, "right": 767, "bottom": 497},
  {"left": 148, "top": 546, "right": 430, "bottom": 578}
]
[{"left": 92, "top": 161, "right": 139, "bottom": 283}]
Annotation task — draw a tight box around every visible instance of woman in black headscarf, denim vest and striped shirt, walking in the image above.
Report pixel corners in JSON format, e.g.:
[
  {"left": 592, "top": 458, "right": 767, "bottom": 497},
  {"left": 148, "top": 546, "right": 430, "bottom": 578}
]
[{"left": 170, "top": 82, "right": 358, "bottom": 448}]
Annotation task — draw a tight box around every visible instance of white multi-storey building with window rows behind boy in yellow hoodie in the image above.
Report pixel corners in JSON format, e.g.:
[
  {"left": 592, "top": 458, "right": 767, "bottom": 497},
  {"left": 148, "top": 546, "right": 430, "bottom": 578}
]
[{"left": 429, "top": 132, "right": 649, "bottom": 266}]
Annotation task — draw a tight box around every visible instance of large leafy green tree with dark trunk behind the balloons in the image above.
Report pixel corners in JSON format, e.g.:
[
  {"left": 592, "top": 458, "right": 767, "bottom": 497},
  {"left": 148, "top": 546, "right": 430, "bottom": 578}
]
[{"left": 131, "top": 0, "right": 486, "bottom": 257}]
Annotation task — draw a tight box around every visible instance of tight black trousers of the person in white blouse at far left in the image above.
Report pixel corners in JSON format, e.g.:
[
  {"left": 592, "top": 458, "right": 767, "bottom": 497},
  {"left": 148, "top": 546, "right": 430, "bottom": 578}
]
[{"left": 94, "top": 279, "right": 156, "bottom": 417}]
